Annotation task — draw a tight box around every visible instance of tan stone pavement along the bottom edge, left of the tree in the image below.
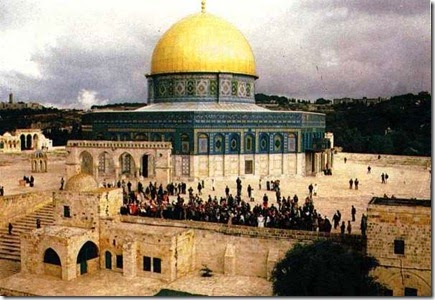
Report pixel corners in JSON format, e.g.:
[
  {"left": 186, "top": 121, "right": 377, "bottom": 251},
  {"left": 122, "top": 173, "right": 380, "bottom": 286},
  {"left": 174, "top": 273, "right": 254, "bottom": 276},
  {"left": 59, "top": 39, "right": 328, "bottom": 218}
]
[{"left": 0, "top": 265, "right": 272, "bottom": 297}]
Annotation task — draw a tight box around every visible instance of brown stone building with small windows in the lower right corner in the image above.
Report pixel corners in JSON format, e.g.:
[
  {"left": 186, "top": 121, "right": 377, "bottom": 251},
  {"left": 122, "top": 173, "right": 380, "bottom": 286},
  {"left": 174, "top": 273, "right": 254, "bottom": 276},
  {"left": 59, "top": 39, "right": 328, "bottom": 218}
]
[{"left": 367, "top": 198, "right": 432, "bottom": 296}]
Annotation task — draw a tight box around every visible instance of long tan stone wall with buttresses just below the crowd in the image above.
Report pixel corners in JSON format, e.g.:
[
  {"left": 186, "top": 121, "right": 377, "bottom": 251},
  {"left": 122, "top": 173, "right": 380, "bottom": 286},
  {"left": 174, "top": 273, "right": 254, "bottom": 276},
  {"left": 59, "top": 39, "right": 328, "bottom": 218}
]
[{"left": 121, "top": 216, "right": 365, "bottom": 278}]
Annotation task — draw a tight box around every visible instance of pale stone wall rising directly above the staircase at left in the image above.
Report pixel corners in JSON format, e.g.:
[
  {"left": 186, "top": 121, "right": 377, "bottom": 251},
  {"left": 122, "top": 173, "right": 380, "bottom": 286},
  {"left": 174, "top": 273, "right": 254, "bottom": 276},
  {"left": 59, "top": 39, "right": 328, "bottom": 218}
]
[{"left": 0, "top": 192, "right": 52, "bottom": 226}]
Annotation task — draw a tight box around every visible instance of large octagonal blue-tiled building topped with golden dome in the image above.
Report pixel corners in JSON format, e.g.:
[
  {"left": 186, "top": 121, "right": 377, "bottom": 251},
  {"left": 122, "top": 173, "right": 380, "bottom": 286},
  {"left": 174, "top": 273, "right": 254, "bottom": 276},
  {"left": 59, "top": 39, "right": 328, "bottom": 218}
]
[{"left": 83, "top": 5, "right": 332, "bottom": 180}]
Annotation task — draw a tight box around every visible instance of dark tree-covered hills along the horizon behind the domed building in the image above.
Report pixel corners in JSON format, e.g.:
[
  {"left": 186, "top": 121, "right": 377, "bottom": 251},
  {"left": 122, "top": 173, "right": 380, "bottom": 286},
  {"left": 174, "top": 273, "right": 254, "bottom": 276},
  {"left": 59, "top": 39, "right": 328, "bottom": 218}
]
[{"left": 0, "top": 92, "right": 432, "bottom": 156}]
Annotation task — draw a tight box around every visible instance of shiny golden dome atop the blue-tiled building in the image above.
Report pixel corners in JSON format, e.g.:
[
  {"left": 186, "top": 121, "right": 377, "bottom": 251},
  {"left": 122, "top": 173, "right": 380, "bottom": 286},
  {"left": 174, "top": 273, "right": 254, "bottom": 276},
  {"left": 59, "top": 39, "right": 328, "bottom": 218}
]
[{"left": 151, "top": 12, "right": 257, "bottom": 76}]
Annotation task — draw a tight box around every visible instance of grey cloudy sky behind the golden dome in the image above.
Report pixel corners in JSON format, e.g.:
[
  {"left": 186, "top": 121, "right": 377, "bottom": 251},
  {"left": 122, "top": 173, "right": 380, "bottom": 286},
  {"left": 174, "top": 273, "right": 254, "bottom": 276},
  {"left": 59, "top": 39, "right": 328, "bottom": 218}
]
[{"left": 0, "top": 0, "right": 431, "bottom": 108}]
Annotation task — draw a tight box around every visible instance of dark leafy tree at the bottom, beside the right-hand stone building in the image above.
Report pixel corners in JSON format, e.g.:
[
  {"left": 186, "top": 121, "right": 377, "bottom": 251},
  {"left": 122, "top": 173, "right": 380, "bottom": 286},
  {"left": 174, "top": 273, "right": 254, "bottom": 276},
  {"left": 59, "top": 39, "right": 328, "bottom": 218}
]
[{"left": 272, "top": 240, "right": 385, "bottom": 296}]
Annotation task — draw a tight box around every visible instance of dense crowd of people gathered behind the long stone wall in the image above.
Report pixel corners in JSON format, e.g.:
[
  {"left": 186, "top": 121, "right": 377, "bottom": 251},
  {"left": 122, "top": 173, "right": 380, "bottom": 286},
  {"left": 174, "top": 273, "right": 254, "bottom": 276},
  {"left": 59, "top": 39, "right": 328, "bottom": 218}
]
[{"left": 120, "top": 178, "right": 364, "bottom": 234}]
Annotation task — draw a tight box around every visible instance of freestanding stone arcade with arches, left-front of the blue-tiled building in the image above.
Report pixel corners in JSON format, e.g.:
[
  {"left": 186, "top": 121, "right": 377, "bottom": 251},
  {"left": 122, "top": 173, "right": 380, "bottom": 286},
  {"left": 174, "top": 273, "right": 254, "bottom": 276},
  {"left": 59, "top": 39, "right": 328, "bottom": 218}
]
[{"left": 66, "top": 140, "right": 172, "bottom": 185}]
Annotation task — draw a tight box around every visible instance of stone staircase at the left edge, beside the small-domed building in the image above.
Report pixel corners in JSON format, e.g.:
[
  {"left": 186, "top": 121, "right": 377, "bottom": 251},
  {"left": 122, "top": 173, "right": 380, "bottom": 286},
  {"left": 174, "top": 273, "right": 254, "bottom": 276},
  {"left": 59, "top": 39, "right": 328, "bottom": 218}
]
[{"left": 0, "top": 203, "right": 54, "bottom": 261}]
